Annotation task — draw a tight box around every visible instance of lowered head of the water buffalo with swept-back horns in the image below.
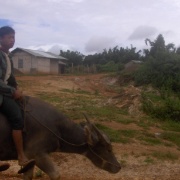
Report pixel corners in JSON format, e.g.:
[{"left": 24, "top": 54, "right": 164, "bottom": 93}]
[{"left": 84, "top": 115, "right": 121, "bottom": 173}]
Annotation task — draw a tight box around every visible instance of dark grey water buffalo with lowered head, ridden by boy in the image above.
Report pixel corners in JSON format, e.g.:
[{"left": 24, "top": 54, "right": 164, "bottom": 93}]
[{"left": 0, "top": 97, "right": 121, "bottom": 180}]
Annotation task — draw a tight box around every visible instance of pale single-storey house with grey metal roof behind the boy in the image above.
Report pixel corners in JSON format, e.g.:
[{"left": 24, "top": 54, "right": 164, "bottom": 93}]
[{"left": 11, "top": 48, "right": 67, "bottom": 74}]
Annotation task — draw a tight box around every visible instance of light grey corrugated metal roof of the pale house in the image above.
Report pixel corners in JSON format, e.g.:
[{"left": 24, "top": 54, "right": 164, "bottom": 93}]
[{"left": 14, "top": 48, "right": 67, "bottom": 60}]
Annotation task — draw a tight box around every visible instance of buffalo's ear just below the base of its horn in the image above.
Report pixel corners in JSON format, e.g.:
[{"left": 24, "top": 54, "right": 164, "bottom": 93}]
[{"left": 84, "top": 125, "right": 99, "bottom": 146}]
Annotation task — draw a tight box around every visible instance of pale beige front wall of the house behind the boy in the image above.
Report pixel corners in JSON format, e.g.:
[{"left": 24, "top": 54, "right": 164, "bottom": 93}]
[{"left": 12, "top": 51, "right": 50, "bottom": 73}]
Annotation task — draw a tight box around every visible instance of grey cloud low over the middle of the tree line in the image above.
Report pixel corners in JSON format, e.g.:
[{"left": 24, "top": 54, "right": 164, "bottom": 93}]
[{"left": 85, "top": 37, "right": 115, "bottom": 52}]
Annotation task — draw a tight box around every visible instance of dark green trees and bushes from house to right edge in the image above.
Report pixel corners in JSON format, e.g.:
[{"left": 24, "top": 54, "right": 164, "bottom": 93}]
[{"left": 60, "top": 34, "right": 180, "bottom": 121}]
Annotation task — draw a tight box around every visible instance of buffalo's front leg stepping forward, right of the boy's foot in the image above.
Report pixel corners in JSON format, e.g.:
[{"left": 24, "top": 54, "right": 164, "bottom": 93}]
[{"left": 35, "top": 154, "right": 60, "bottom": 180}]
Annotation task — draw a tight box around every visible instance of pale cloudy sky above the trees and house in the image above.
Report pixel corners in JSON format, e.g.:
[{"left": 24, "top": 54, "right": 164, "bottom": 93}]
[{"left": 0, "top": 0, "right": 180, "bottom": 55}]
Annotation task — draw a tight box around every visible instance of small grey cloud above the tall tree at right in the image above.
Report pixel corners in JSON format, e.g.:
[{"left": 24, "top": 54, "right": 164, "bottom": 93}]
[{"left": 128, "top": 26, "right": 157, "bottom": 40}]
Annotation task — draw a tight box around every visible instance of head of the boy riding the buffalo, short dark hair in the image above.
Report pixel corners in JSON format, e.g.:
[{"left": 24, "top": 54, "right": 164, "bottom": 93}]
[{"left": 0, "top": 26, "right": 15, "bottom": 50}]
